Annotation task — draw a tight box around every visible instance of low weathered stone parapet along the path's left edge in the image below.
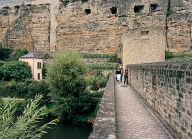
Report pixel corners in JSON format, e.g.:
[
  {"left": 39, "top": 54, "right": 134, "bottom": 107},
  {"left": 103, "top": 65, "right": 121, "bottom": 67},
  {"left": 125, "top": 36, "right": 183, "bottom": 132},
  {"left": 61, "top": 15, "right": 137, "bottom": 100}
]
[{"left": 88, "top": 76, "right": 116, "bottom": 139}]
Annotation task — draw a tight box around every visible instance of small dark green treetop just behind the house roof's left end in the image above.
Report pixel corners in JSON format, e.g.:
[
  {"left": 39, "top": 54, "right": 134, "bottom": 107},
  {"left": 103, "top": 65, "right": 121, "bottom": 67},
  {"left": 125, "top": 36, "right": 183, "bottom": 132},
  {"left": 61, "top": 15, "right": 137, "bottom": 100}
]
[{"left": 10, "top": 48, "right": 28, "bottom": 61}]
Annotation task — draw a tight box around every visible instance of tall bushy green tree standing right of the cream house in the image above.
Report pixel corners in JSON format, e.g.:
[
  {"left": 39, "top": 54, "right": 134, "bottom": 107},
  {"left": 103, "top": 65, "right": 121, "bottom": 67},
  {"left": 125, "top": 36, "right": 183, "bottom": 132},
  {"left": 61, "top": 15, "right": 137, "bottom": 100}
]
[{"left": 47, "top": 51, "right": 87, "bottom": 119}]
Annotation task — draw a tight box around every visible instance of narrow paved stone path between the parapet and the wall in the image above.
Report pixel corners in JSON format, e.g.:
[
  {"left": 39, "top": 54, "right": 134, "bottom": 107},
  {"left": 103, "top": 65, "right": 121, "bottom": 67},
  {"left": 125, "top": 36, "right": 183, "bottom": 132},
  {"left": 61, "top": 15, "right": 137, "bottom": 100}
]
[{"left": 115, "top": 83, "right": 175, "bottom": 139}]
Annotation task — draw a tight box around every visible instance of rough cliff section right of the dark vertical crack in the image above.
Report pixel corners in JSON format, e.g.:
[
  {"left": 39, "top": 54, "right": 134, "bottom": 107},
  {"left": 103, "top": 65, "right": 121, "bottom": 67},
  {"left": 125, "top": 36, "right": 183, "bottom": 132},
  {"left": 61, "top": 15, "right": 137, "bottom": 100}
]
[{"left": 167, "top": 0, "right": 192, "bottom": 52}]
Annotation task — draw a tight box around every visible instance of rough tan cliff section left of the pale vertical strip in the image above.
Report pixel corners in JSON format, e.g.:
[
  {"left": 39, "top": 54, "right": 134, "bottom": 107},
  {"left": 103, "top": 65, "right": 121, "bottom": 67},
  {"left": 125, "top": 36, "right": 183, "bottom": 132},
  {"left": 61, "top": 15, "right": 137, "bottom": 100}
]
[{"left": 0, "top": 4, "right": 51, "bottom": 51}]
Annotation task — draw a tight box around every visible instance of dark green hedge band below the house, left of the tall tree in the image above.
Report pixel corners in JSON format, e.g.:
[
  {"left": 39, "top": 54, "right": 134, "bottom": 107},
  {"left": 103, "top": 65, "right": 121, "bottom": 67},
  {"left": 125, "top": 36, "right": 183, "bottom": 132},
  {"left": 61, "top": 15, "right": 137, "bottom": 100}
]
[{"left": 0, "top": 79, "right": 50, "bottom": 101}]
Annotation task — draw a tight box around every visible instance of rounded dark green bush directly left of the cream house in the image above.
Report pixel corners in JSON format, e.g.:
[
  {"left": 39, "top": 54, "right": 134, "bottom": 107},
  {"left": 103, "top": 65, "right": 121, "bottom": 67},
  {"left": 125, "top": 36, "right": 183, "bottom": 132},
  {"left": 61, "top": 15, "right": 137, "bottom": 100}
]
[{"left": 0, "top": 61, "right": 31, "bottom": 81}]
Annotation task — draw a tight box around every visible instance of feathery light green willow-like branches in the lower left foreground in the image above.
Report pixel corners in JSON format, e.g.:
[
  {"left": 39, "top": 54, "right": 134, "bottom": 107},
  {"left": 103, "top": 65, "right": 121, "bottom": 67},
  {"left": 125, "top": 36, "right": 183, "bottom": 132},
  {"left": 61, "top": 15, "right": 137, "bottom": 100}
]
[{"left": 0, "top": 95, "right": 58, "bottom": 139}]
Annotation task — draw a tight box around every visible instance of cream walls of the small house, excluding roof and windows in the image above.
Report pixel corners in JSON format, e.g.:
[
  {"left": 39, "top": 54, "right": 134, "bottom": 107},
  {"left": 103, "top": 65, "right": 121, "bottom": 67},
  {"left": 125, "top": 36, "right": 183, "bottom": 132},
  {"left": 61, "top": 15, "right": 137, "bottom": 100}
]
[{"left": 19, "top": 58, "right": 43, "bottom": 80}]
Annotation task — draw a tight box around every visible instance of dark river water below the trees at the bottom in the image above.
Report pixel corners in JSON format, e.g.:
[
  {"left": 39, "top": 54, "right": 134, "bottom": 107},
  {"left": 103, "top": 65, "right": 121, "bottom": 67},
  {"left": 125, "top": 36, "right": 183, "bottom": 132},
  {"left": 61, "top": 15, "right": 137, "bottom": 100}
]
[{"left": 42, "top": 123, "right": 92, "bottom": 139}]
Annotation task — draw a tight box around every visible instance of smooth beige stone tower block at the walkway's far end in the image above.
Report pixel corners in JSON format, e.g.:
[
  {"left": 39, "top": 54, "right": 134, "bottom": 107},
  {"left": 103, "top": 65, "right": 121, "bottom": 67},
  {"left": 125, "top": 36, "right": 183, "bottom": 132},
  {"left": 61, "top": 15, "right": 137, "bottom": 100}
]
[{"left": 123, "top": 27, "right": 166, "bottom": 68}]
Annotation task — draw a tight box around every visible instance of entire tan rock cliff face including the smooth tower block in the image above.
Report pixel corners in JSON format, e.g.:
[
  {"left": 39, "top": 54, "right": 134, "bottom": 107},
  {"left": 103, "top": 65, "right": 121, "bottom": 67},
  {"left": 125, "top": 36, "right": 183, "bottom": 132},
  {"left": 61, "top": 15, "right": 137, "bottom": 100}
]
[{"left": 0, "top": 0, "right": 192, "bottom": 64}]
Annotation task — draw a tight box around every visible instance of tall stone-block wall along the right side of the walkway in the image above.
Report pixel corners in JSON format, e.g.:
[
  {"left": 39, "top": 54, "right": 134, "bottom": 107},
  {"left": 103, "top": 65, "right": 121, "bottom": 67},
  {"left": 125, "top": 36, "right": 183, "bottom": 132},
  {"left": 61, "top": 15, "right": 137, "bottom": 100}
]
[{"left": 127, "top": 60, "right": 192, "bottom": 139}]
